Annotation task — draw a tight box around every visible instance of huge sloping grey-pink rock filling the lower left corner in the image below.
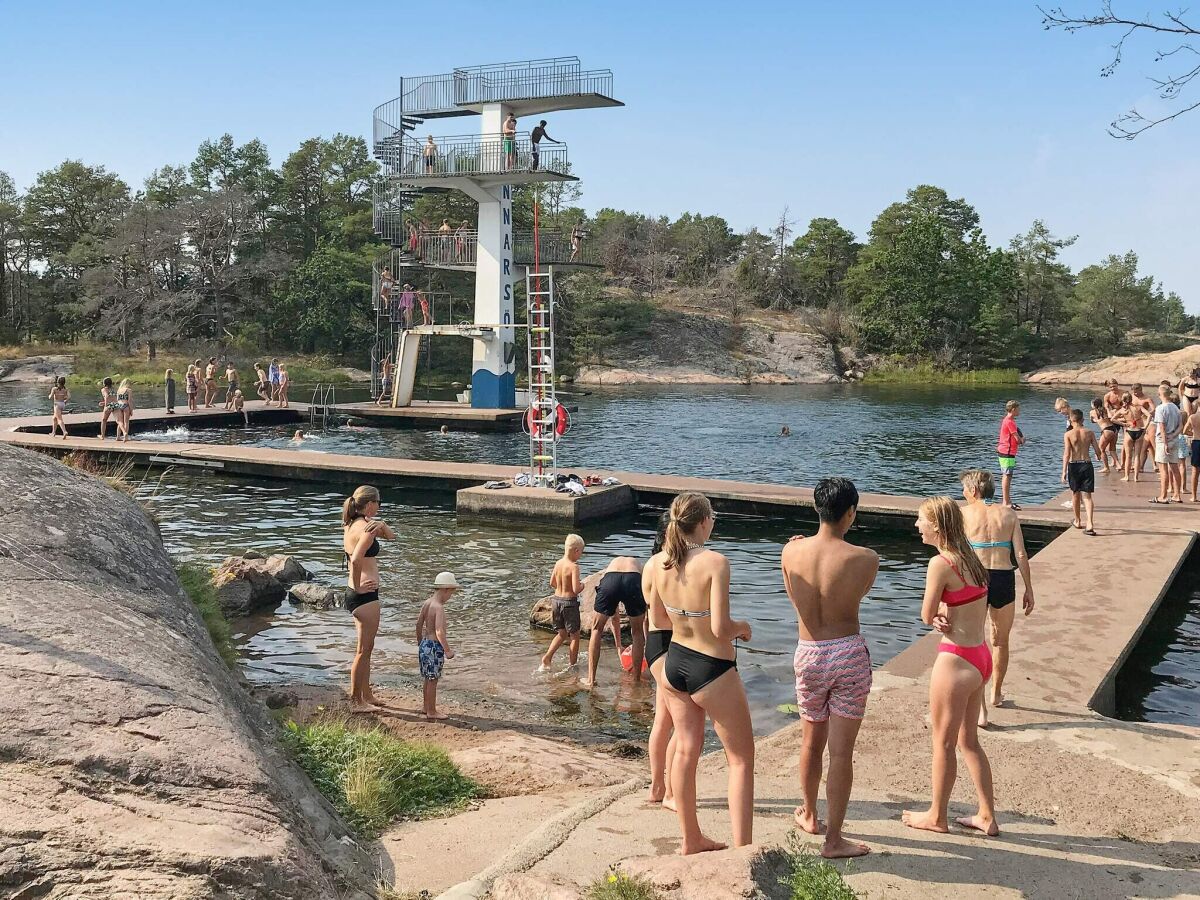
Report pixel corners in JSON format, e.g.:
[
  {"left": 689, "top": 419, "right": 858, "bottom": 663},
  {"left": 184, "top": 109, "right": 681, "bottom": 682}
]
[{"left": 0, "top": 445, "right": 374, "bottom": 900}]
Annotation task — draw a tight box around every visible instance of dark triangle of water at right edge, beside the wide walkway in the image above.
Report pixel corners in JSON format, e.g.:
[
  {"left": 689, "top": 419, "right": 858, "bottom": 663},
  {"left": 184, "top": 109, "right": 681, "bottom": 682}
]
[{"left": 1117, "top": 550, "right": 1200, "bottom": 726}]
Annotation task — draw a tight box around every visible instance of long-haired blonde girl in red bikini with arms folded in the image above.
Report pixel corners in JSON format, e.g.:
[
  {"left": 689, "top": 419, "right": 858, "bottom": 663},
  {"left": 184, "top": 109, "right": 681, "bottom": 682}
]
[{"left": 904, "top": 497, "right": 1000, "bottom": 836}]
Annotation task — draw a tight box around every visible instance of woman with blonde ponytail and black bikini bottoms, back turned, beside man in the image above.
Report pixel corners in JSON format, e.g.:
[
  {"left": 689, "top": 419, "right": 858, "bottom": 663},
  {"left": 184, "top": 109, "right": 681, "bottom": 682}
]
[{"left": 642, "top": 493, "right": 754, "bottom": 856}]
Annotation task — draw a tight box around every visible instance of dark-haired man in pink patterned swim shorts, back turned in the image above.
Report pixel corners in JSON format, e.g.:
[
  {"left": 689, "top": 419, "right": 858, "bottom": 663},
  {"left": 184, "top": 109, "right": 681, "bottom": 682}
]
[{"left": 782, "top": 478, "right": 880, "bottom": 859}]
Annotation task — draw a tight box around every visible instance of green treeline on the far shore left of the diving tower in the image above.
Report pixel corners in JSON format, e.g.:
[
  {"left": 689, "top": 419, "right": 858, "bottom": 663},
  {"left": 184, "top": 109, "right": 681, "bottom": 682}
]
[{"left": 0, "top": 134, "right": 378, "bottom": 354}]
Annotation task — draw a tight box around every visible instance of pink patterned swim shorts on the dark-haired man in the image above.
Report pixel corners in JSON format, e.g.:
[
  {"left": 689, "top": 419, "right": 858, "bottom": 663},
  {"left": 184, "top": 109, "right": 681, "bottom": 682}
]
[{"left": 793, "top": 635, "right": 871, "bottom": 722}]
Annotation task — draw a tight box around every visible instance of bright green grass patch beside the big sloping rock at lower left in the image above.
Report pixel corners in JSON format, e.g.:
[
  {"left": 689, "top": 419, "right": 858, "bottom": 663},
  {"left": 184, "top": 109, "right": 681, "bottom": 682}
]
[{"left": 283, "top": 720, "right": 481, "bottom": 836}]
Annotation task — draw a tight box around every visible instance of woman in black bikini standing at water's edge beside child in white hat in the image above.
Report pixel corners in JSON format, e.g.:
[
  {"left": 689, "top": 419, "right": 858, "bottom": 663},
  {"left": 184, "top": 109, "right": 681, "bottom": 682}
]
[{"left": 342, "top": 485, "right": 396, "bottom": 713}]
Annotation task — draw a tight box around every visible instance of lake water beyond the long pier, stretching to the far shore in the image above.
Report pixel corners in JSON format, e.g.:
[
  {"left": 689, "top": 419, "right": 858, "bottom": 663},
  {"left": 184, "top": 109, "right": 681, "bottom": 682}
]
[{"left": 14, "top": 385, "right": 1091, "bottom": 503}]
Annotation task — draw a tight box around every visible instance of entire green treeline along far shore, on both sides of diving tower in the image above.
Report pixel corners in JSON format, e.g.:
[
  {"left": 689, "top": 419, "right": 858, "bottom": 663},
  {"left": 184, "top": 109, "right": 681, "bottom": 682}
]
[{"left": 0, "top": 134, "right": 1196, "bottom": 367}]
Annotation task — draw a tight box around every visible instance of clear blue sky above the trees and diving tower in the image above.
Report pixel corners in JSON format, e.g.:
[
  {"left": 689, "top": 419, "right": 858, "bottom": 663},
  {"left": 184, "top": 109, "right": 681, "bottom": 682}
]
[{"left": 0, "top": 0, "right": 1200, "bottom": 312}]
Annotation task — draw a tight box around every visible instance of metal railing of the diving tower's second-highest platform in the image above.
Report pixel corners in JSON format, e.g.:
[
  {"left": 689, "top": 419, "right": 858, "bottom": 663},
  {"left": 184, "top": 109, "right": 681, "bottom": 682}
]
[{"left": 376, "top": 131, "right": 570, "bottom": 180}]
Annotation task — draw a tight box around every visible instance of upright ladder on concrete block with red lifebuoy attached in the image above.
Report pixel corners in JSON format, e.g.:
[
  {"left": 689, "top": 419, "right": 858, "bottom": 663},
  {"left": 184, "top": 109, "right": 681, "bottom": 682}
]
[{"left": 526, "top": 266, "right": 558, "bottom": 487}]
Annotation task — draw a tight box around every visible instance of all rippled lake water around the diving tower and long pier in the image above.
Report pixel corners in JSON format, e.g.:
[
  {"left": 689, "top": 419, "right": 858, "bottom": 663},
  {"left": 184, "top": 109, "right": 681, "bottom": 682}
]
[{"left": 0, "top": 385, "right": 1194, "bottom": 734}]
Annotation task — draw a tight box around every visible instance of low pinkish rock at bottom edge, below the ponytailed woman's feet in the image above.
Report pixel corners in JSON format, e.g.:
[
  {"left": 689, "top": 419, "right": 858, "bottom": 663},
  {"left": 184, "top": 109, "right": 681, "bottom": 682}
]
[{"left": 616, "top": 845, "right": 792, "bottom": 900}]
